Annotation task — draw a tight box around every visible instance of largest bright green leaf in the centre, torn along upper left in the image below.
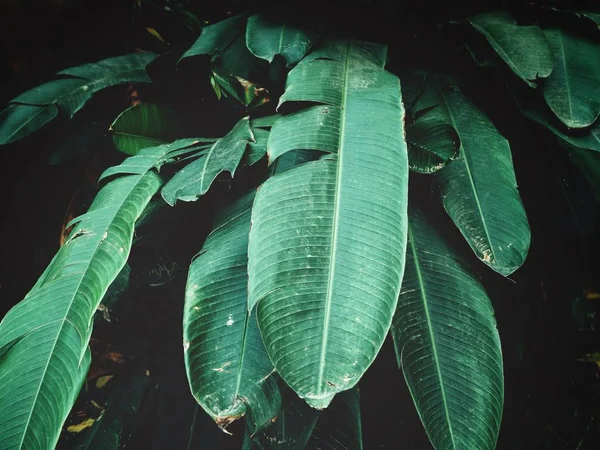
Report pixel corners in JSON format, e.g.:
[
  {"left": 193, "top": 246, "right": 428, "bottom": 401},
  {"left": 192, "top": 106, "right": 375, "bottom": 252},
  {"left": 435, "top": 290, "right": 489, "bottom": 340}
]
[{"left": 248, "top": 41, "right": 408, "bottom": 408}]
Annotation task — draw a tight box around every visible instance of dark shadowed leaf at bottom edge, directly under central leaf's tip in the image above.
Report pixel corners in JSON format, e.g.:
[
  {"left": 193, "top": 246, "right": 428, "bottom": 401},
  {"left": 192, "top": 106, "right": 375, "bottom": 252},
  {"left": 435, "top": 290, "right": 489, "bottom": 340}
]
[{"left": 306, "top": 387, "right": 363, "bottom": 450}]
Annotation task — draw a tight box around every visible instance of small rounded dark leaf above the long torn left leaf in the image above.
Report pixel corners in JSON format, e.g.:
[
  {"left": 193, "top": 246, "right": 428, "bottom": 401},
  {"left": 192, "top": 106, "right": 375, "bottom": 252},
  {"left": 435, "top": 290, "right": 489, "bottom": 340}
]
[{"left": 110, "top": 103, "right": 177, "bottom": 155}]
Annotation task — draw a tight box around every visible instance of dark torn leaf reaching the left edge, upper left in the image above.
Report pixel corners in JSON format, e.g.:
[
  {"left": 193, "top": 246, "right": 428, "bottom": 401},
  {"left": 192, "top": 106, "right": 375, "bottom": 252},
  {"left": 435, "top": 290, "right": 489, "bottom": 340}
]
[{"left": 0, "top": 52, "right": 158, "bottom": 144}]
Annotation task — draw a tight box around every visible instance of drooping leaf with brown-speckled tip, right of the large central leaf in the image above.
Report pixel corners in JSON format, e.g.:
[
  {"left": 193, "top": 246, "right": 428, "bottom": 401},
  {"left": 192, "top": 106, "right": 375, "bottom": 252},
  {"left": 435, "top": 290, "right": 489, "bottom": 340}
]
[{"left": 416, "top": 76, "right": 531, "bottom": 276}]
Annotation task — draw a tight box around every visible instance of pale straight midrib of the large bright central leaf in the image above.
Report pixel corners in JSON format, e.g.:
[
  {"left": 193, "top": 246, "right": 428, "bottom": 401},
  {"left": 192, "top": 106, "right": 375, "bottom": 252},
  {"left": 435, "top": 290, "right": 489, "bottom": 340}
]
[{"left": 317, "top": 40, "right": 350, "bottom": 395}]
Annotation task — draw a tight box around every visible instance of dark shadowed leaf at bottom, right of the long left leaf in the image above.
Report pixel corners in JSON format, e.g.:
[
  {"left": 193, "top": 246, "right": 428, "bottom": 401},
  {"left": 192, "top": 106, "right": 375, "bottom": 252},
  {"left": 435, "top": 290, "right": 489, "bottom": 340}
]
[{"left": 74, "top": 369, "right": 150, "bottom": 450}]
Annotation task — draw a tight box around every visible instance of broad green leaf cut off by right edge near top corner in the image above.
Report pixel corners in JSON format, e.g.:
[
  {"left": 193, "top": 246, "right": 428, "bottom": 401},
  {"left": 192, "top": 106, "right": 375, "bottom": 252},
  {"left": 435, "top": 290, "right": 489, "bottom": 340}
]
[{"left": 543, "top": 28, "right": 600, "bottom": 128}]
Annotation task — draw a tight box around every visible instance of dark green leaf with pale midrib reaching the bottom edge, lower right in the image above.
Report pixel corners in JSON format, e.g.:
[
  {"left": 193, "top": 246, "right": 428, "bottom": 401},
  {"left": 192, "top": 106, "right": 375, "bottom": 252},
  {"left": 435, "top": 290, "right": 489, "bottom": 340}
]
[{"left": 392, "top": 213, "right": 504, "bottom": 450}]
